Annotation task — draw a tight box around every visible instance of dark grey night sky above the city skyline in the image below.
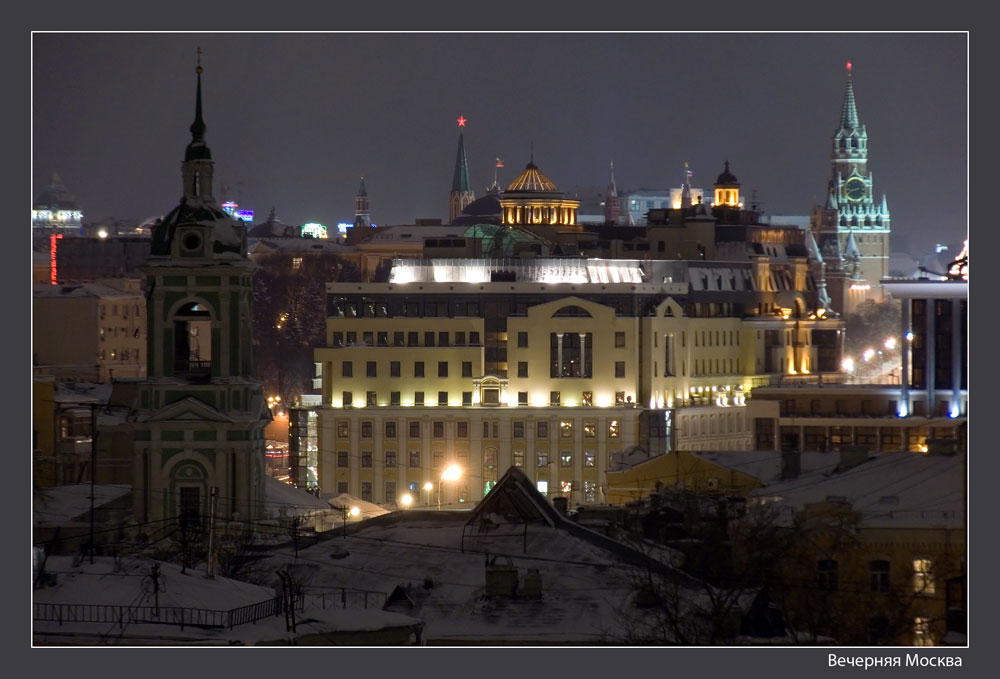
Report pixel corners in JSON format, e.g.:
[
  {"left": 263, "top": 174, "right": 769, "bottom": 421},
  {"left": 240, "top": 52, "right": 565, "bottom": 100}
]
[{"left": 32, "top": 33, "right": 968, "bottom": 254}]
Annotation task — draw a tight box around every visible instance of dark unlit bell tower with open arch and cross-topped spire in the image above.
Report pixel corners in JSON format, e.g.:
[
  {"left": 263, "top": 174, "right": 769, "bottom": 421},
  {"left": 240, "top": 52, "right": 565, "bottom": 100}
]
[{"left": 129, "top": 57, "right": 271, "bottom": 522}]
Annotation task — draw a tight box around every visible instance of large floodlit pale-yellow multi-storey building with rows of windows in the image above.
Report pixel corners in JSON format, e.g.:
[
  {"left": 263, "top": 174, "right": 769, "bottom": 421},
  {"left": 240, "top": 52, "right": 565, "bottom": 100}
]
[{"left": 314, "top": 258, "right": 841, "bottom": 506}]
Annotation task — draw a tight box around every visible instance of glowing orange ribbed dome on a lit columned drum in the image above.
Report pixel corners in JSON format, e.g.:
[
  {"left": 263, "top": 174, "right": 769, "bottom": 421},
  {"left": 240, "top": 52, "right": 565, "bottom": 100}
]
[{"left": 500, "top": 160, "right": 581, "bottom": 231}]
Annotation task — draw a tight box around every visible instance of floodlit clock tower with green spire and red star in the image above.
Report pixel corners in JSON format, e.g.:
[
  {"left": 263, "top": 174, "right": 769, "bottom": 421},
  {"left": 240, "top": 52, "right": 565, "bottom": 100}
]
[{"left": 812, "top": 62, "right": 891, "bottom": 315}]
